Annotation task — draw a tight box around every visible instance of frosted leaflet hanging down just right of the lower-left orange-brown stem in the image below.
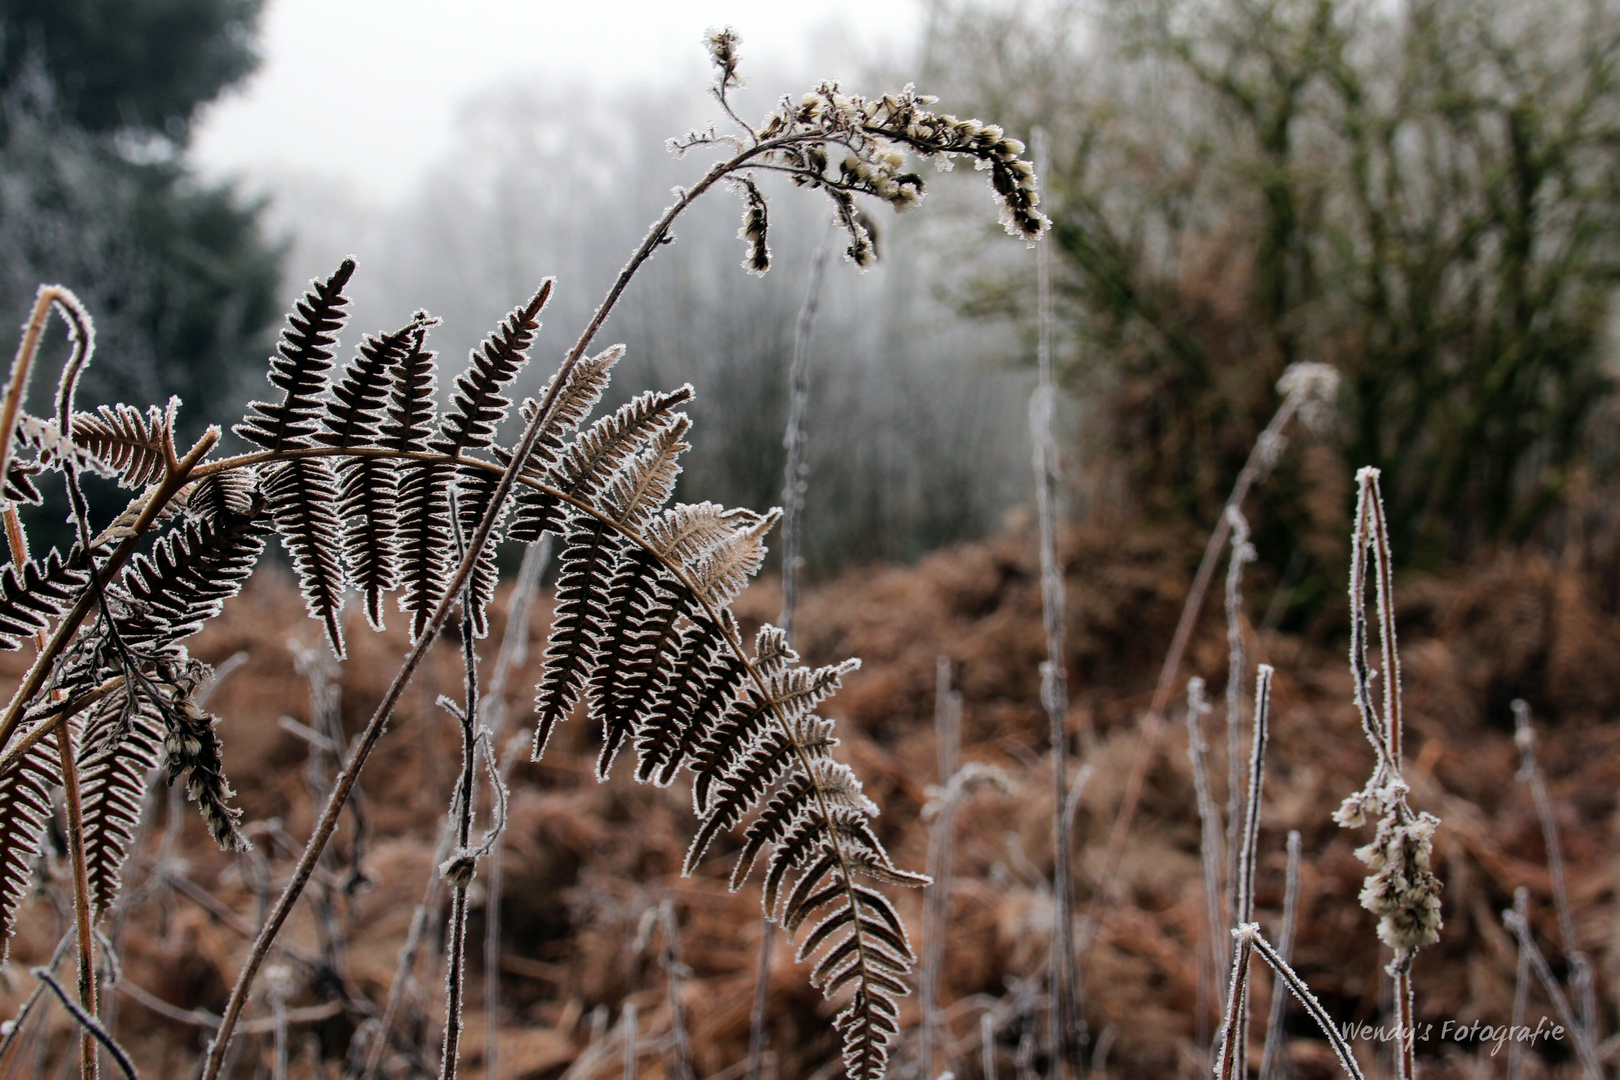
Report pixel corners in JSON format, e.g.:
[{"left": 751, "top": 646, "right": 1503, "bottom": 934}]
[{"left": 76, "top": 688, "right": 164, "bottom": 916}]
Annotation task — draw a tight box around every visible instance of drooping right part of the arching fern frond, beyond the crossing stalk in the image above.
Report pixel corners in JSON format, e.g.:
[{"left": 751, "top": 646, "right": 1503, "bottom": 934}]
[{"left": 525, "top": 346, "right": 925, "bottom": 1078}]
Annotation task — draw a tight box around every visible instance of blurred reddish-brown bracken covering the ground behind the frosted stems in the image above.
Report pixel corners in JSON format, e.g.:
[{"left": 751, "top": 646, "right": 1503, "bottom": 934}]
[{"left": 0, "top": 518, "right": 1620, "bottom": 1080}]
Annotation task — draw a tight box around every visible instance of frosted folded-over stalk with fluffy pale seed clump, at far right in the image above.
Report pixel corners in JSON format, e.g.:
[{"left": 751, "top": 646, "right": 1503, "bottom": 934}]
[{"left": 1333, "top": 468, "right": 1440, "bottom": 1080}]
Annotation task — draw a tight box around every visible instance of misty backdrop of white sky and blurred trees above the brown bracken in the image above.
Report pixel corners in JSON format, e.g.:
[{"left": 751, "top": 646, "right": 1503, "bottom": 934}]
[{"left": 0, "top": 0, "right": 1620, "bottom": 602}]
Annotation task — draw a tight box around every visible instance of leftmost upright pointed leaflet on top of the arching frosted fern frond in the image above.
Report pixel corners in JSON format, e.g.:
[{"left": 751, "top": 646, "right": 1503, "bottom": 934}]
[{"left": 235, "top": 259, "right": 355, "bottom": 450}]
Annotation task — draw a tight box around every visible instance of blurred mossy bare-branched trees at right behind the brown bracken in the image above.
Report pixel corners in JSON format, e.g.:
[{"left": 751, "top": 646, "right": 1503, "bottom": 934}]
[{"left": 930, "top": 0, "right": 1620, "bottom": 565}]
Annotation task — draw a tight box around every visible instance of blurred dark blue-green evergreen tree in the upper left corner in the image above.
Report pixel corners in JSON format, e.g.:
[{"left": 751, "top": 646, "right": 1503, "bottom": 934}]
[{"left": 0, "top": 0, "right": 280, "bottom": 429}]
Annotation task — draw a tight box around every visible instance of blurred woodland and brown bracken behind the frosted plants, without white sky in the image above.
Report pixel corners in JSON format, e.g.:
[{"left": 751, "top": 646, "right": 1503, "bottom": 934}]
[{"left": 0, "top": 0, "right": 1620, "bottom": 1077}]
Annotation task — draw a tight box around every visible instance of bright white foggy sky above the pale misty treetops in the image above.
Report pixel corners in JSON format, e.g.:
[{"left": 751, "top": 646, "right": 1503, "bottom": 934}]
[{"left": 193, "top": 0, "right": 922, "bottom": 202}]
